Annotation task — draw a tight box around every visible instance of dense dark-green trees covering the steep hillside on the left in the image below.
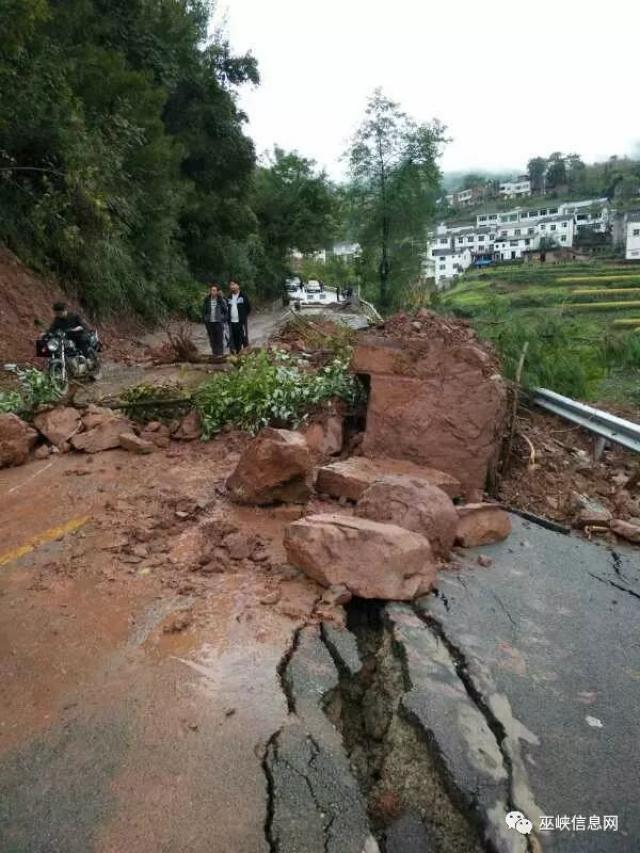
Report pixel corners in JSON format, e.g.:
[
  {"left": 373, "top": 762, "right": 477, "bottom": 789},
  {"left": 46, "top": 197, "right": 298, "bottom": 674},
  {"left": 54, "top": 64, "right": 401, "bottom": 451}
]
[{"left": 0, "top": 0, "right": 333, "bottom": 318}]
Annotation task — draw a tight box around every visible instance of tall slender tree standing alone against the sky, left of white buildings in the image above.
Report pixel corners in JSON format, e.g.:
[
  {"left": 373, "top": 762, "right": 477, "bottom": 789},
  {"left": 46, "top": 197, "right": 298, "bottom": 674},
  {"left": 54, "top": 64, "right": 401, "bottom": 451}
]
[{"left": 348, "top": 89, "right": 446, "bottom": 307}]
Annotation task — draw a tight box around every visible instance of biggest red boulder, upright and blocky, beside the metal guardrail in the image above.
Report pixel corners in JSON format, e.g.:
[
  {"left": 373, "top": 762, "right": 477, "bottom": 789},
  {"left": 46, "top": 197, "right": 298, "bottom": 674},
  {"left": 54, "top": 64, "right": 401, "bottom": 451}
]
[{"left": 352, "top": 311, "right": 506, "bottom": 499}]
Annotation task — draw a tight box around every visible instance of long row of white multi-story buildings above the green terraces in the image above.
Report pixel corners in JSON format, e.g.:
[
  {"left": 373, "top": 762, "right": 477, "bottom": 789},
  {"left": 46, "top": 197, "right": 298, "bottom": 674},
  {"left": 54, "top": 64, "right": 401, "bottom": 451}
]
[{"left": 423, "top": 199, "right": 608, "bottom": 287}]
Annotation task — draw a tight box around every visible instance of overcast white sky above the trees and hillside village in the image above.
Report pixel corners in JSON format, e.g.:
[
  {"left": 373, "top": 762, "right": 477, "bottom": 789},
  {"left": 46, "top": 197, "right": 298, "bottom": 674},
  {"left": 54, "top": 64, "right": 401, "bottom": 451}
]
[{"left": 217, "top": 0, "right": 640, "bottom": 177}]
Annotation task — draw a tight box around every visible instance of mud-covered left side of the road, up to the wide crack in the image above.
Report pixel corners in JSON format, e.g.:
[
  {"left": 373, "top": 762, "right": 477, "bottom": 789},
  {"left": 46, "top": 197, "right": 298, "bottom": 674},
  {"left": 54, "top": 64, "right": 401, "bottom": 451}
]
[{"left": 0, "top": 433, "right": 482, "bottom": 853}]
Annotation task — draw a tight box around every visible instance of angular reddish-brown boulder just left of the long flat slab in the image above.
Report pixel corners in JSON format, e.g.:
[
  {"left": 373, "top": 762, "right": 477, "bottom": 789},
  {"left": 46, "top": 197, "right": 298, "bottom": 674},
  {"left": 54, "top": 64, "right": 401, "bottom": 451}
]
[{"left": 227, "top": 428, "right": 313, "bottom": 505}]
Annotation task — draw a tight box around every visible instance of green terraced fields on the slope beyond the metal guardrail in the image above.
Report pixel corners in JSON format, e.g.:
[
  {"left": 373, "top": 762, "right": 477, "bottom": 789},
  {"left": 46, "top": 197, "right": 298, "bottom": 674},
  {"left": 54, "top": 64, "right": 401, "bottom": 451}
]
[{"left": 438, "top": 262, "right": 640, "bottom": 407}]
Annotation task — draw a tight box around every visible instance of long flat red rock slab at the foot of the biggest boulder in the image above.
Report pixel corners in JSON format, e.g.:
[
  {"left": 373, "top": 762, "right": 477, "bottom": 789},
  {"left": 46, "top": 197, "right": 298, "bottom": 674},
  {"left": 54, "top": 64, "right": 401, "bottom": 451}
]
[{"left": 316, "top": 456, "right": 462, "bottom": 501}]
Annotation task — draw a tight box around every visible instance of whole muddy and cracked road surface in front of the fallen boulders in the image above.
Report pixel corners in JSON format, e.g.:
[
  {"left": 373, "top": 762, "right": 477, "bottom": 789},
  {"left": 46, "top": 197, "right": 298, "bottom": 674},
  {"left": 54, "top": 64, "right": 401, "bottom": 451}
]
[{"left": 0, "top": 432, "right": 640, "bottom": 853}]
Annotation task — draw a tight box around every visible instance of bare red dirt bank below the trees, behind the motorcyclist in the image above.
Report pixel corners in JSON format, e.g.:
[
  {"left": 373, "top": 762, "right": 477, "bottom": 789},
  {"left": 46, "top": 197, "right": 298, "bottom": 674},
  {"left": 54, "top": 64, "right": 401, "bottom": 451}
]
[{"left": 0, "top": 245, "right": 151, "bottom": 365}]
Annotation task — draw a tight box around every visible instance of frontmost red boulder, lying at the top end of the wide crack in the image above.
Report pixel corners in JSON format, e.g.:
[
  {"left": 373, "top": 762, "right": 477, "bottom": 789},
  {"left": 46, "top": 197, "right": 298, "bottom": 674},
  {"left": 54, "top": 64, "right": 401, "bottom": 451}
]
[{"left": 284, "top": 514, "right": 437, "bottom": 601}]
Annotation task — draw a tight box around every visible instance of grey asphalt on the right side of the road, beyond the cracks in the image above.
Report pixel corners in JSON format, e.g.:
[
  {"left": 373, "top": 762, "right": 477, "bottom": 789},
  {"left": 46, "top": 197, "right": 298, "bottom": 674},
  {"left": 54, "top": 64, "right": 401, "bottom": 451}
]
[{"left": 417, "top": 516, "right": 640, "bottom": 853}]
